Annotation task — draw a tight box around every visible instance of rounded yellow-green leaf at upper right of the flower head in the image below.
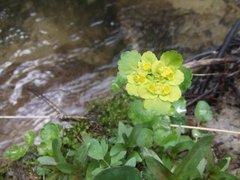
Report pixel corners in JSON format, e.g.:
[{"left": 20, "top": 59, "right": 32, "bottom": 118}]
[{"left": 160, "top": 50, "right": 183, "bottom": 69}]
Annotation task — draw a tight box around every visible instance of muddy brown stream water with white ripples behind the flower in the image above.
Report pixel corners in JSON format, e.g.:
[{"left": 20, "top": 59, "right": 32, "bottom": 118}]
[{"left": 0, "top": 0, "right": 240, "bottom": 172}]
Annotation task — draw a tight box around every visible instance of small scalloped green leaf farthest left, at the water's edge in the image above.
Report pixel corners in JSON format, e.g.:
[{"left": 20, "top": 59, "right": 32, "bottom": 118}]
[{"left": 3, "top": 145, "right": 27, "bottom": 161}]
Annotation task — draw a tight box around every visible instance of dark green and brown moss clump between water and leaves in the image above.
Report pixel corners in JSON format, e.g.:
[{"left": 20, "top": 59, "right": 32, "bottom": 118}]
[{"left": 63, "top": 93, "right": 130, "bottom": 148}]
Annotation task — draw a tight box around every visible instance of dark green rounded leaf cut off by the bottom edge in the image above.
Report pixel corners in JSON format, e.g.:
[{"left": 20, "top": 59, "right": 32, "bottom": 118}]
[{"left": 94, "top": 166, "right": 141, "bottom": 180}]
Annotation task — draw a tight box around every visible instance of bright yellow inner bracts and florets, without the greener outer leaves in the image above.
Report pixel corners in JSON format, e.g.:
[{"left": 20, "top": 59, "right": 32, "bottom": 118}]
[{"left": 126, "top": 51, "right": 184, "bottom": 105}]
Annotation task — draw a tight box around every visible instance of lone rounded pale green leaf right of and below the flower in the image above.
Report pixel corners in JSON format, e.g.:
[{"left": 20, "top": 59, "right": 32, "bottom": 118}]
[{"left": 194, "top": 101, "right": 213, "bottom": 122}]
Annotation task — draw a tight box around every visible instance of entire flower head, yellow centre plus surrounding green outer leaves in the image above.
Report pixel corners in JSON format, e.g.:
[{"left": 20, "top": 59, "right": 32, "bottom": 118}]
[{"left": 115, "top": 50, "right": 192, "bottom": 115}]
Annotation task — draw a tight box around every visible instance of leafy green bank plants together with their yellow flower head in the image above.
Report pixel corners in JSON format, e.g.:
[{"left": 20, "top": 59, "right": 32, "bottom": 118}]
[{"left": 2, "top": 51, "right": 237, "bottom": 180}]
